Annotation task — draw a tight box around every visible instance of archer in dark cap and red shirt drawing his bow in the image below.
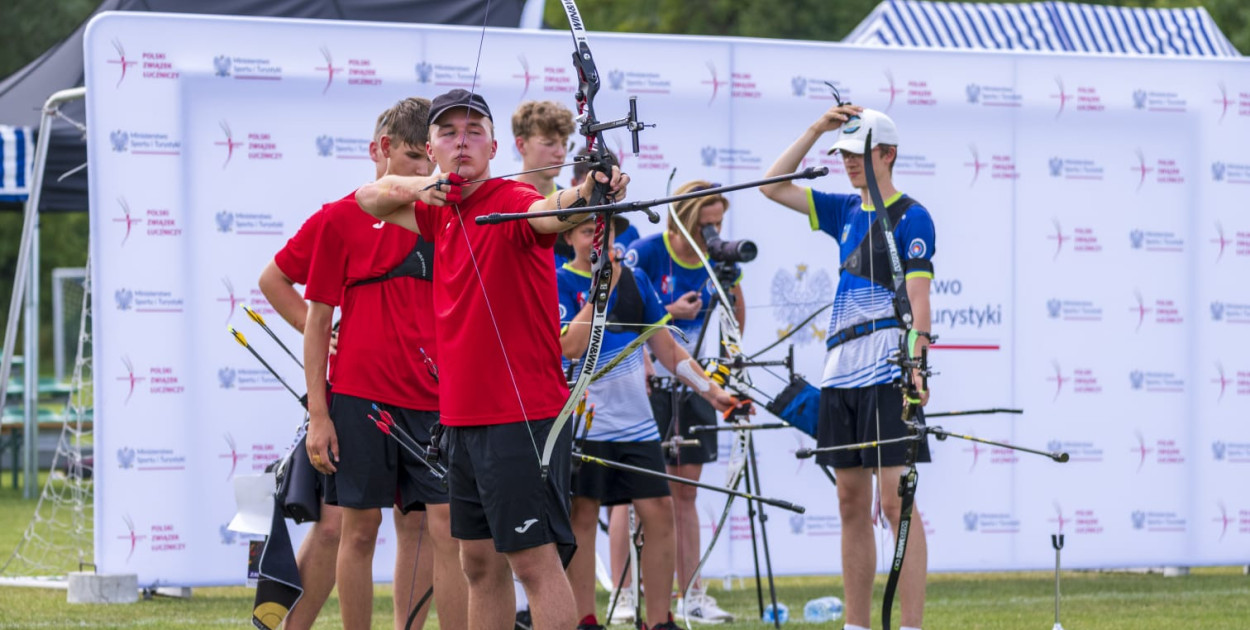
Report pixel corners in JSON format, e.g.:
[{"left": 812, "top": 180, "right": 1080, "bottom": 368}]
[{"left": 356, "top": 90, "right": 629, "bottom": 630}]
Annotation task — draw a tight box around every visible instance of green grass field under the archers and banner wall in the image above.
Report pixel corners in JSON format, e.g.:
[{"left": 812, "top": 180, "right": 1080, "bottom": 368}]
[{"left": 0, "top": 477, "right": 1250, "bottom": 630}]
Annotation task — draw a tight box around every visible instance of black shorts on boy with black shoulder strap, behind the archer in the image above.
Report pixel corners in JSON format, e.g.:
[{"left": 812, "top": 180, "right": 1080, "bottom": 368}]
[{"left": 325, "top": 394, "right": 448, "bottom": 511}]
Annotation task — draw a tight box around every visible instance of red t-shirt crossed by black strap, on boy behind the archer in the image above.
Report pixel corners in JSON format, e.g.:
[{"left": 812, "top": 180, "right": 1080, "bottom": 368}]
[{"left": 304, "top": 193, "right": 439, "bottom": 410}]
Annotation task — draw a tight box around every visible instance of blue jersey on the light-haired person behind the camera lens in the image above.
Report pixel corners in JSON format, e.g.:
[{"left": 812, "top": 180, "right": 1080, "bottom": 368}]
[{"left": 625, "top": 230, "right": 743, "bottom": 360}]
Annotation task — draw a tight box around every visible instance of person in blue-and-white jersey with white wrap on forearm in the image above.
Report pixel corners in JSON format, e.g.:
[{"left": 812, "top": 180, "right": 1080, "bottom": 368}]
[{"left": 556, "top": 220, "right": 735, "bottom": 630}]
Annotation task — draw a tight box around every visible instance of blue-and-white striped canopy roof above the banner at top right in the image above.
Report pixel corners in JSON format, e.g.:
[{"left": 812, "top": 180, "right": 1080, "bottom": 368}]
[{"left": 844, "top": 0, "right": 1241, "bottom": 58}]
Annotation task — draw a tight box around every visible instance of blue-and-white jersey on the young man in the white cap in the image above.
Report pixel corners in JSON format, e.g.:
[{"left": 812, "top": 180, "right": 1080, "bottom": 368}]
[{"left": 808, "top": 189, "right": 934, "bottom": 388}]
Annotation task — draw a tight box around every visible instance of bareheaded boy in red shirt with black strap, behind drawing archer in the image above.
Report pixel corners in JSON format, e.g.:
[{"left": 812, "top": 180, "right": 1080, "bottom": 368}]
[{"left": 304, "top": 97, "right": 466, "bottom": 629}]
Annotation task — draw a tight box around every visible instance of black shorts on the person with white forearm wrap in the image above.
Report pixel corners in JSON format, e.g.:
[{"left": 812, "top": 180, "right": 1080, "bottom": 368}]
[{"left": 573, "top": 440, "right": 670, "bottom": 505}]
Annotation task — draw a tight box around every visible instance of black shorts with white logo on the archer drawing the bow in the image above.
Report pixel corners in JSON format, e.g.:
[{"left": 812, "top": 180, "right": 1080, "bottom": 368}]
[{"left": 445, "top": 420, "right": 575, "bottom": 558}]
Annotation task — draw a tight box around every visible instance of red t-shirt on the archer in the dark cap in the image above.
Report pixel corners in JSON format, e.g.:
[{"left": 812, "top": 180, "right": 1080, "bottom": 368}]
[{"left": 415, "top": 180, "right": 569, "bottom": 426}]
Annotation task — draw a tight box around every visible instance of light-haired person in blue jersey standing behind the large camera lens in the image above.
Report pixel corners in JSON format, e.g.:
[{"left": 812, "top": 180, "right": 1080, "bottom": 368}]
[{"left": 614, "top": 180, "right": 754, "bottom": 621}]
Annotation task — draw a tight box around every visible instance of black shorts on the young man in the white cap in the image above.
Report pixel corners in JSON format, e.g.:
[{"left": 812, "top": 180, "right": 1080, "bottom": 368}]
[{"left": 816, "top": 384, "right": 929, "bottom": 469}]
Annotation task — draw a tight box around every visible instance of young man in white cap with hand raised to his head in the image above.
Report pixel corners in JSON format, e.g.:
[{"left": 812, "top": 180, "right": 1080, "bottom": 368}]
[{"left": 760, "top": 104, "right": 934, "bottom": 630}]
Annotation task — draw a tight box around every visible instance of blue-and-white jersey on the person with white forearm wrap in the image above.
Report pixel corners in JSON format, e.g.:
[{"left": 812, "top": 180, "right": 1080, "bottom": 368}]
[{"left": 555, "top": 265, "right": 671, "bottom": 441}]
